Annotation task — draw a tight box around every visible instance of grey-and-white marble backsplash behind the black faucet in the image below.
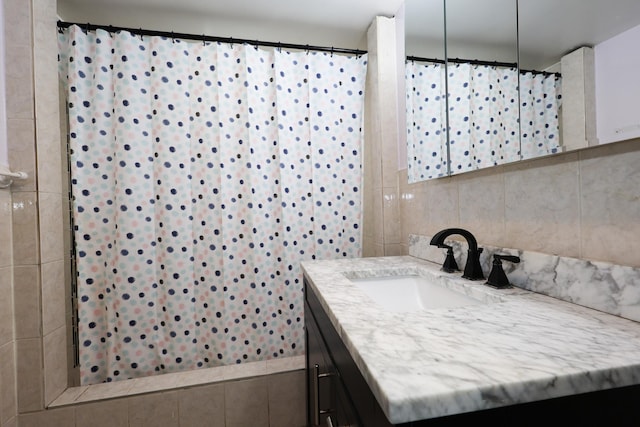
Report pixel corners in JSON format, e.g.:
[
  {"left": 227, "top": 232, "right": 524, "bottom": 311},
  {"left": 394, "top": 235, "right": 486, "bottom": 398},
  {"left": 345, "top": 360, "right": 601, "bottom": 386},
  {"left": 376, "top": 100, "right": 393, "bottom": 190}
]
[{"left": 409, "top": 236, "right": 640, "bottom": 321}]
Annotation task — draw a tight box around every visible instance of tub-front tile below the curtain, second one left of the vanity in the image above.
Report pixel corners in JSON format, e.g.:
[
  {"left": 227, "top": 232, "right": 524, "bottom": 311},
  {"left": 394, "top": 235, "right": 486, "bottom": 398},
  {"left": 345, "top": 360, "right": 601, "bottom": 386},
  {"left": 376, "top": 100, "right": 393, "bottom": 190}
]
[{"left": 224, "top": 377, "right": 269, "bottom": 427}]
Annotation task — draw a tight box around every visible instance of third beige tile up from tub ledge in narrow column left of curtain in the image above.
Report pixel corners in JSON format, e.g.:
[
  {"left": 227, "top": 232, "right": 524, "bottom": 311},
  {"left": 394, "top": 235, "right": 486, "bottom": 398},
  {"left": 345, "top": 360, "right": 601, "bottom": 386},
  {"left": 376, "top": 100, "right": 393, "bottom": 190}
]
[{"left": 38, "top": 193, "right": 64, "bottom": 263}]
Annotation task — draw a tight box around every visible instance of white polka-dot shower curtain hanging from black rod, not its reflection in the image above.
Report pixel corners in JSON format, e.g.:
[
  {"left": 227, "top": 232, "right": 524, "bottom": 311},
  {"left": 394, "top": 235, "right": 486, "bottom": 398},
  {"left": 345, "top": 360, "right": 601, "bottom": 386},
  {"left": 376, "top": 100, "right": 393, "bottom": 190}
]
[{"left": 60, "top": 26, "right": 366, "bottom": 384}]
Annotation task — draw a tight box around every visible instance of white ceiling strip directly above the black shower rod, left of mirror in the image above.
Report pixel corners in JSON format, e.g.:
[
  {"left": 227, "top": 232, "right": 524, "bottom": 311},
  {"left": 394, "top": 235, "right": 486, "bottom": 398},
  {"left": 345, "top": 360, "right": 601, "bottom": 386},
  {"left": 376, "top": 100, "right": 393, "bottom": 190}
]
[{"left": 58, "top": 0, "right": 403, "bottom": 49}]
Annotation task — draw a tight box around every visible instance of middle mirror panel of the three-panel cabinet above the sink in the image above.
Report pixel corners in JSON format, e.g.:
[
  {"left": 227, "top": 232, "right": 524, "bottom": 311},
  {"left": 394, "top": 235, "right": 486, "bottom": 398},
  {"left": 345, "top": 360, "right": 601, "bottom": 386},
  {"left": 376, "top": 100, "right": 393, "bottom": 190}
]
[{"left": 445, "top": 0, "right": 520, "bottom": 174}]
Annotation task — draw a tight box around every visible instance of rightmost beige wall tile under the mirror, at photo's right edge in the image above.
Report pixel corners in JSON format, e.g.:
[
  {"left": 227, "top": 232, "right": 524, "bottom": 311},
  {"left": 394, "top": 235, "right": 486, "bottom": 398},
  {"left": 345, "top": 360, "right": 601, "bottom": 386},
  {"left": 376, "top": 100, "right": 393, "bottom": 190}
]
[{"left": 580, "top": 140, "right": 640, "bottom": 267}]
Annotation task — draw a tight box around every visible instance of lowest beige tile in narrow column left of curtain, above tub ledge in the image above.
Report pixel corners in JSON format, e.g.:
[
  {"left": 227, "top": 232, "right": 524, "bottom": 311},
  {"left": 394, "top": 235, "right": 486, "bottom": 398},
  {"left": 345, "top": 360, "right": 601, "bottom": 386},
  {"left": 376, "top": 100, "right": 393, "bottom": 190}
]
[{"left": 43, "top": 325, "right": 67, "bottom": 405}]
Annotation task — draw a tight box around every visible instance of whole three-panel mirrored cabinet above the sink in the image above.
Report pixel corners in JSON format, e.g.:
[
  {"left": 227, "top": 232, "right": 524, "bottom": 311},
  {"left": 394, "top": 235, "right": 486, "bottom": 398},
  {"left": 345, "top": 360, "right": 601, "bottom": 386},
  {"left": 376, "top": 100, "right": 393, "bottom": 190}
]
[{"left": 405, "top": 0, "right": 640, "bottom": 182}]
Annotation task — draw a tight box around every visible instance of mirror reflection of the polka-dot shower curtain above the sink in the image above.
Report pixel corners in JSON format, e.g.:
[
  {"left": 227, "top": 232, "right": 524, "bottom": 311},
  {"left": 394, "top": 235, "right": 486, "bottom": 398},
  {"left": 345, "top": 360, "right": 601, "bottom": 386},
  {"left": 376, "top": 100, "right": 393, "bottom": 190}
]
[{"left": 406, "top": 61, "right": 561, "bottom": 182}]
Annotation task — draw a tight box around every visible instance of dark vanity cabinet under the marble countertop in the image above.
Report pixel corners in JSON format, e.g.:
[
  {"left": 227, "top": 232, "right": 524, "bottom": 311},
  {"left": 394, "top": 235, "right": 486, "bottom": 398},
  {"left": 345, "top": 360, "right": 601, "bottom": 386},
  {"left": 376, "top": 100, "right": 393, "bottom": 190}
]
[{"left": 304, "top": 278, "right": 640, "bottom": 427}]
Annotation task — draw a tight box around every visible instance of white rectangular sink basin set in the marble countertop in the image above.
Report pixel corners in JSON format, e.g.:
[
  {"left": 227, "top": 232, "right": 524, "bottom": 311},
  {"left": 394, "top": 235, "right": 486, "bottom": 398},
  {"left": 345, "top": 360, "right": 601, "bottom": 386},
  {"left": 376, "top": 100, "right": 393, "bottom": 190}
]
[{"left": 350, "top": 275, "right": 485, "bottom": 313}]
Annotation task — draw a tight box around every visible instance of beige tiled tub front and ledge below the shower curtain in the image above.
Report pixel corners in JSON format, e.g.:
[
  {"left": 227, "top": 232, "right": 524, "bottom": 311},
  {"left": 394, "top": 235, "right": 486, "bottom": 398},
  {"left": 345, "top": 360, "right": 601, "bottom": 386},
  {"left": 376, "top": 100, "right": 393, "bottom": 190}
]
[{"left": 36, "top": 356, "right": 306, "bottom": 427}]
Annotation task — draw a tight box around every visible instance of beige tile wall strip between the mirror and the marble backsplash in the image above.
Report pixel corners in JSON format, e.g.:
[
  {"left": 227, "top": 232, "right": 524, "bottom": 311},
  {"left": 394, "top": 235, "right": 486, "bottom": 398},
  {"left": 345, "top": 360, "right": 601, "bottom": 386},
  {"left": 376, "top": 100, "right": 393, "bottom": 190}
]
[{"left": 399, "top": 140, "right": 640, "bottom": 267}]
